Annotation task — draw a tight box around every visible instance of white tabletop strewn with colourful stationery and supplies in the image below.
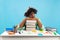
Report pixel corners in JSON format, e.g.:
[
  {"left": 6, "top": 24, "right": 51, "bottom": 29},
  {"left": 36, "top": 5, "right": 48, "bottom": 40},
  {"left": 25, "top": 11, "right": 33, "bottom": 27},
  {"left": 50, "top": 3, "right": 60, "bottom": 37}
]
[{"left": 1, "top": 31, "right": 60, "bottom": 36}]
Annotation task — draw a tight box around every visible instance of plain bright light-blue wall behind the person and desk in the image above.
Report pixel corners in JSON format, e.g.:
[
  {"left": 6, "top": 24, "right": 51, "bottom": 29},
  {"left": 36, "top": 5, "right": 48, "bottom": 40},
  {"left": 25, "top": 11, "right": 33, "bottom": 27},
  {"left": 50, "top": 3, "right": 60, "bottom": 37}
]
[{"left": 0, "top": 0, "right": 60, "bottom": 33}]
